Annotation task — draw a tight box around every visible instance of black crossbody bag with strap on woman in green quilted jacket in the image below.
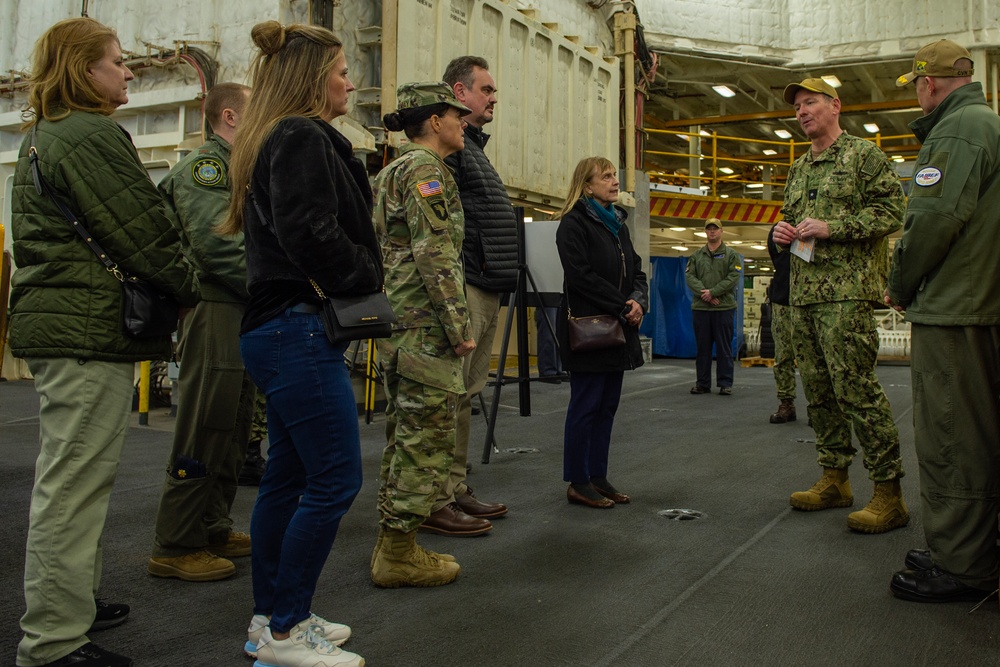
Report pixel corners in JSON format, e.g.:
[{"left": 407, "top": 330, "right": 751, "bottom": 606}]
[{"left": 28, "top": 123, "right": 180, "bottom": 340}]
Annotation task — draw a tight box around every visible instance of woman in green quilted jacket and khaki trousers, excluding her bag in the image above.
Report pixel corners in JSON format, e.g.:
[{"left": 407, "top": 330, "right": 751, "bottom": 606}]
[{"left": 10, "top": 18, "right": 197, "bottom": 667}]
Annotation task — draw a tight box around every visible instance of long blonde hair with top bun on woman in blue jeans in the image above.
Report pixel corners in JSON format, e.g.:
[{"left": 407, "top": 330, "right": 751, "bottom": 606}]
[{"left": 219, "top": 21, "right": 342, "bottom": 234}]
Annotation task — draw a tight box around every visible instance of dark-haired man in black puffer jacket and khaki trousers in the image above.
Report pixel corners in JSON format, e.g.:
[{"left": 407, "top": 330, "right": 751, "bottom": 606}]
[{"left": 421, "top": 56, "right": 517, "bottom": 536}]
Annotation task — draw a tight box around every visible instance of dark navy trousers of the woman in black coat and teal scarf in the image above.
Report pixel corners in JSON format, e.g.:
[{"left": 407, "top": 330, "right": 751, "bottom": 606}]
[{"left": 563, "top": 371, "right": 625, "bottom": 484}]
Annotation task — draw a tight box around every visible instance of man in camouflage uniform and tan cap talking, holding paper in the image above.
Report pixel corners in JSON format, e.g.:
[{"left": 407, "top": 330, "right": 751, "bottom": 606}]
[{"left": 774, "top": 79, "right": 910, "bottom": 533}]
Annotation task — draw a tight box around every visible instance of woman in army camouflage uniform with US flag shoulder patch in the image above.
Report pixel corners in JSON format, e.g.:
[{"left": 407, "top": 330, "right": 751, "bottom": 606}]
[{"left": 371, "top": 82, "right": 476, "bottom": 588}]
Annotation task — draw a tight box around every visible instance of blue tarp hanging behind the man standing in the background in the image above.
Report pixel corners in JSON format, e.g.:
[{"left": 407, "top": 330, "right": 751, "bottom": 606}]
[{"left": 639, "top": 256, "right": 743, "bottom": 359}]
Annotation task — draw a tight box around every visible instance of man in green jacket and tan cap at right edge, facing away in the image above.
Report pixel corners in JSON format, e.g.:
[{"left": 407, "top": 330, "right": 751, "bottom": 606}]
[{"left": 887, "top": 40, "right": 1000, "bottom": 602}]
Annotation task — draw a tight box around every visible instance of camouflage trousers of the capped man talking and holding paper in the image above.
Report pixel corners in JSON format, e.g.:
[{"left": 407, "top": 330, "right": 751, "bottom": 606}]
[{"left": 792, "top": 301, "right": 903, "bottom": 482}]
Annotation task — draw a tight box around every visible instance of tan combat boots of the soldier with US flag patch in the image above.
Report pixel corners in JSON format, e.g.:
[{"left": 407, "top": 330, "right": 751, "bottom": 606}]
[{"left": 372, "top": 529, "right": 462, "bottom": 588}]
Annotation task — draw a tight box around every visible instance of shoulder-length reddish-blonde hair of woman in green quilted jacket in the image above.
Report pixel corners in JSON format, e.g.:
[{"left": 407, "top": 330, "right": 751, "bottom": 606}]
[{"left": 22, "top": 18, "right": 118, "bottom": 129}]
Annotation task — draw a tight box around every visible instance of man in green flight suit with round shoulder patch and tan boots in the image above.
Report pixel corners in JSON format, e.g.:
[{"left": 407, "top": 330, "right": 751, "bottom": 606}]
[{"left": 147, "top": 83, "right": 256, "bottom": 581}]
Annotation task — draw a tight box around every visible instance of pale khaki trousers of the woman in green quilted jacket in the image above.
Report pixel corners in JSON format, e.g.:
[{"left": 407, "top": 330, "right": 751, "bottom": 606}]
[{"left": 17, "top": 359, "right": 135, "bottom": 667}]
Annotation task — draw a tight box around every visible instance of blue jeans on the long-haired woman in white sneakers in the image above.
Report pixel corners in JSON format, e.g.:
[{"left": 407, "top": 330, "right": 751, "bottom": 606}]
[{"left": 240, "top": 310, "right": 362, "bottom": 632}]
